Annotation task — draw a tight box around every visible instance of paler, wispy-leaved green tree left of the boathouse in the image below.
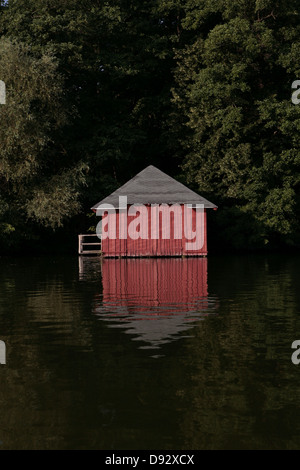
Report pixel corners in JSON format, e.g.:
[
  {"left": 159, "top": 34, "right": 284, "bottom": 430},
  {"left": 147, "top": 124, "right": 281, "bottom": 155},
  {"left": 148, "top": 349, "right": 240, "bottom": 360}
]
[{"left": 0, "top": 38, "right": 83, "bottom": 243}]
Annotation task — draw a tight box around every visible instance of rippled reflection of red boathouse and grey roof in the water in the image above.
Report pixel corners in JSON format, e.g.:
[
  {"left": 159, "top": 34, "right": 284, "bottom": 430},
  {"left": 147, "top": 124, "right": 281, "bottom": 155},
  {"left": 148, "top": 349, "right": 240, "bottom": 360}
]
[{"left": 95, "top": 258, "right": 215, "bottom": 347}]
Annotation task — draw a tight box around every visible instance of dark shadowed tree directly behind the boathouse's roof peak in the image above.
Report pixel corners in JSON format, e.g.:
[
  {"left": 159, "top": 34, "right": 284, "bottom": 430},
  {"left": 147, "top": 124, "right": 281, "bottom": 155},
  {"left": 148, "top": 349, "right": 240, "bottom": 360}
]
[{"left": 0, "top": 0, "right": 183, "bottom": 250}]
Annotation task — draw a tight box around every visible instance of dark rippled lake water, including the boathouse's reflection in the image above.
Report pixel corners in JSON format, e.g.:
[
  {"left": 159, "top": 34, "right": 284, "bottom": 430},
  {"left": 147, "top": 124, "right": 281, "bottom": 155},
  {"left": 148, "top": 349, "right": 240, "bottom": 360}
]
[{"left": 0, "top": 255, "right": 300, "bottom": 450}]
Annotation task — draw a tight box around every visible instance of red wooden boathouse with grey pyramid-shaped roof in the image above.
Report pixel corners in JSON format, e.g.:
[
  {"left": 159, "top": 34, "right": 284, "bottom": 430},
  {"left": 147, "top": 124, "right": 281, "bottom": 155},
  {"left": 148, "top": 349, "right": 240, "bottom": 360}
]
[{"left": 92, "top": 166, "right": 217, "bottom": 258}]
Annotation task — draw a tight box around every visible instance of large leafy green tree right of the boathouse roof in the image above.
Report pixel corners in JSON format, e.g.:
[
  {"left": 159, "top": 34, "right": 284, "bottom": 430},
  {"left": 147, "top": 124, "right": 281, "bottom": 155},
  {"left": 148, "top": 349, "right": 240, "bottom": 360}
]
[{"left": 173, "top": 0, "right": 300, "bottom": 247}]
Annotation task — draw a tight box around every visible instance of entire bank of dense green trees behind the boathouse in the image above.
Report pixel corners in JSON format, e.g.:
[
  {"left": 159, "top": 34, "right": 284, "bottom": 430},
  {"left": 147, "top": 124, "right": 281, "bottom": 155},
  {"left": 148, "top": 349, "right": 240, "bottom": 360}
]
[{"left": 0, "top": 0, "right": 300, "bottom": 253}]
